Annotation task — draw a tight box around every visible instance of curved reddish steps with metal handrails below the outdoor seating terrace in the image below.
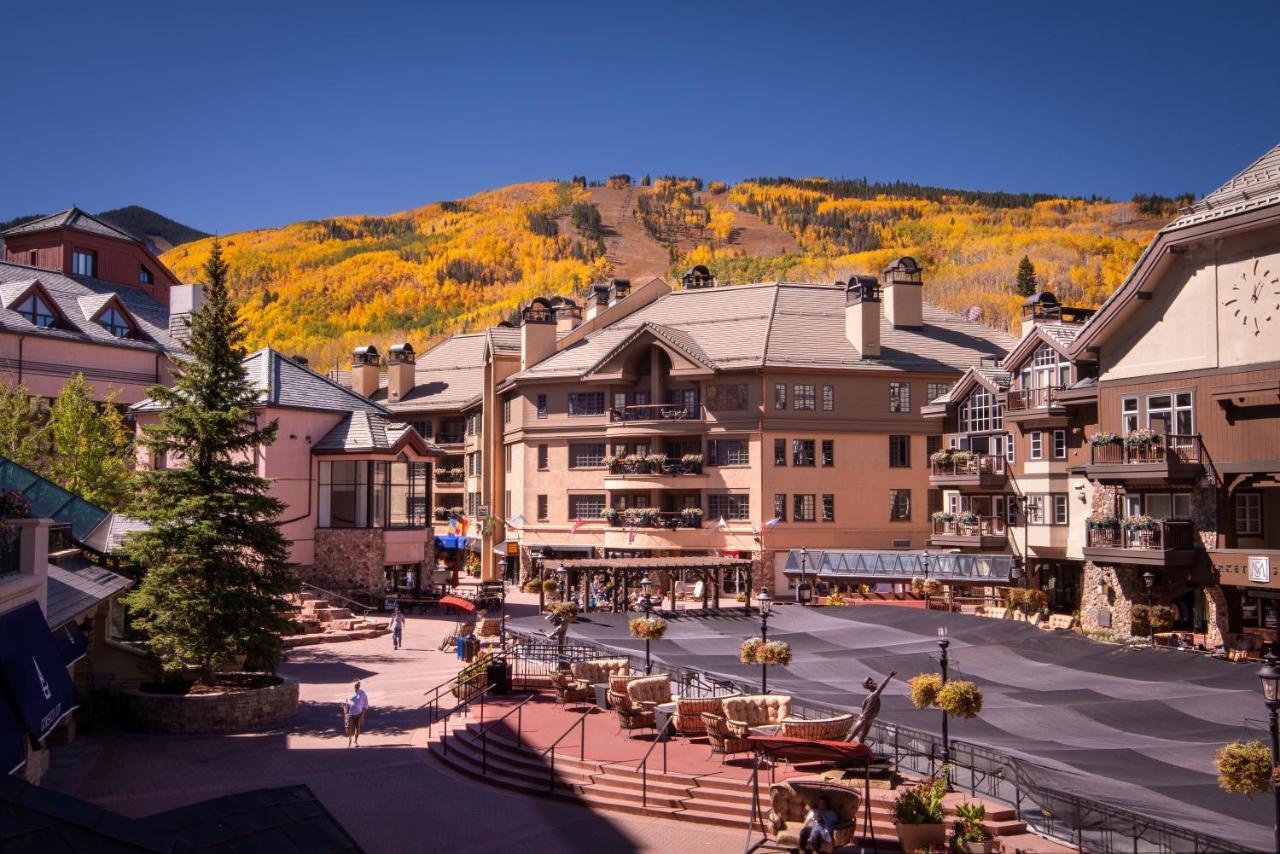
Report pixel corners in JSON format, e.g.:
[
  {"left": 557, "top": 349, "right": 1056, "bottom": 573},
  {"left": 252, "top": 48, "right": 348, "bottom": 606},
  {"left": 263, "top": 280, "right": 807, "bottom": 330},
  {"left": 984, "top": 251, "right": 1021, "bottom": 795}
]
[{"left": 415, "top": 696, "right": 1073, "bottom": 854}]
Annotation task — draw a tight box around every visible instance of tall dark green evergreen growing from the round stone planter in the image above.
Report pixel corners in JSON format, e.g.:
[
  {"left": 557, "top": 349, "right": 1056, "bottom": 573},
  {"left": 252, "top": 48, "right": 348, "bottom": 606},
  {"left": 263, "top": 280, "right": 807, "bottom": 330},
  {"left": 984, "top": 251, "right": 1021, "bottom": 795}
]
[{"left": 127, "top": 242, "right": 293, "bottom": 684}]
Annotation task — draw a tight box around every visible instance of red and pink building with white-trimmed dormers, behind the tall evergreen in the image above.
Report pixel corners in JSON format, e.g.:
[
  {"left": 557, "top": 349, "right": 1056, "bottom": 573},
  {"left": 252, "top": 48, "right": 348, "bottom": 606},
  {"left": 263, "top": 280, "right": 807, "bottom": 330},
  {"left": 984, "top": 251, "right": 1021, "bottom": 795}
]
[{"left": 0, "top": 207, "right": 190, "bottom": 403}]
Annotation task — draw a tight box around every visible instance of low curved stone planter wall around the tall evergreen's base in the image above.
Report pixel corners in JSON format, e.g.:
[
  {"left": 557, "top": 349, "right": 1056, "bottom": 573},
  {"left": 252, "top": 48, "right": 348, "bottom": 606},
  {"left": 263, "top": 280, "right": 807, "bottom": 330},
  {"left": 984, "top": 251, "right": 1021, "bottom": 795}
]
[{"left": 120, "top": 676, "right": 298, "bottom": 735}]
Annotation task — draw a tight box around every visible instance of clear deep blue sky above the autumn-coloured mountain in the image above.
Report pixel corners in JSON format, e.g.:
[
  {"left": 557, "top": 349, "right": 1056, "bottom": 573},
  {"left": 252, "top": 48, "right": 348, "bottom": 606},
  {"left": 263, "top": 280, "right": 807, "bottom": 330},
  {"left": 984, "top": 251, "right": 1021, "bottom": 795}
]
[{"left": 0, "top": 0, "right": 1280, "bottom": 233}]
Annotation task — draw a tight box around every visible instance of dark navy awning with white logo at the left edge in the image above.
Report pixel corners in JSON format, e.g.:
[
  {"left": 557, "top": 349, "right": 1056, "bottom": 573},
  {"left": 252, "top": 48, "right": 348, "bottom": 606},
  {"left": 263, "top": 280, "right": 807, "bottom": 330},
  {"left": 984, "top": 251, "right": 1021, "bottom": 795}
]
[{"left": 0, "top": 602, "right": 76, "bottom": 741}]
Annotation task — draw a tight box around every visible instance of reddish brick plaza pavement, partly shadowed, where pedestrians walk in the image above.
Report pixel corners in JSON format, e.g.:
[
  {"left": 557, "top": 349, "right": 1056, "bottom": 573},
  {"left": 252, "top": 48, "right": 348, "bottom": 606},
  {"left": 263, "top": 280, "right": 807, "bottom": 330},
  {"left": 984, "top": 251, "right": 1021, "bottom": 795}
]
[{"left": 45, "top": 593, "right": 746, "bottom": 853}]
